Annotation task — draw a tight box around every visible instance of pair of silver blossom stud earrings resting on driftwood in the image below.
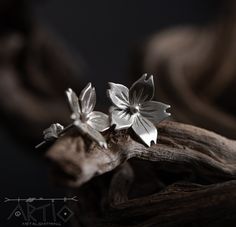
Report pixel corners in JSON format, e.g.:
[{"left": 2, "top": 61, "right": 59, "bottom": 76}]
[{"left": 36, "top": 74, "right": 171, "bottom": 148}]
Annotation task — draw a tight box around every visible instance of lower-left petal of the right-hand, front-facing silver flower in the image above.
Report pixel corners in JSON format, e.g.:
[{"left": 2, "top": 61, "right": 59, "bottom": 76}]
[{"left": 110, "top": 107, "right": 134, "bottom": 130}]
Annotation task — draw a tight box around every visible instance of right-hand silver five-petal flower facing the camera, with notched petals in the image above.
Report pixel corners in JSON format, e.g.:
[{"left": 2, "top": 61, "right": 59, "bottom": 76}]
[{"left": 107, "top": 74, "right": 171, "bottom": 146}]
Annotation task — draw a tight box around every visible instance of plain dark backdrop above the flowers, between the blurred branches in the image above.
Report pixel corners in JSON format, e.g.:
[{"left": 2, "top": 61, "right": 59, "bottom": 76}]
[{"left": 33, "top": 0, "right": 220, "bottom": 94}]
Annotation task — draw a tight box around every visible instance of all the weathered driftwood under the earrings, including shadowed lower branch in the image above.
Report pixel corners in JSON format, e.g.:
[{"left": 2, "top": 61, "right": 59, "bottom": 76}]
[{"left": 46, "top": 121, "right": 236, "bottom": 226}]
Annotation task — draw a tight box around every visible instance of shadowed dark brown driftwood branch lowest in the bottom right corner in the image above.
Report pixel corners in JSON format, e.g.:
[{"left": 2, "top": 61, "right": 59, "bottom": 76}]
[{"left": 100, "top": 180, "right": 236, "bottom": 226}]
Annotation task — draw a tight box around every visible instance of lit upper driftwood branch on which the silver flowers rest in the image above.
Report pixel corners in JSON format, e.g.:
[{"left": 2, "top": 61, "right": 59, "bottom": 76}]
[{"left": 46, "top": 122, "right": 236, "bottom": 187}]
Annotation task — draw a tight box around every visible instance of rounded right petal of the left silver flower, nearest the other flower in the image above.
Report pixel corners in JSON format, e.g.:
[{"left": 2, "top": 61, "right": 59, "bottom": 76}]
[{"left": 87, "top": 111, "right": 110, "bottom": 132}]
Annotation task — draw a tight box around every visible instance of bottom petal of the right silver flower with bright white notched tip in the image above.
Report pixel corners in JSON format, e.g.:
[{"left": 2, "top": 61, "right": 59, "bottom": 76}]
[{"left": 132, "top": 115, "right": 157, "bottom": 147}]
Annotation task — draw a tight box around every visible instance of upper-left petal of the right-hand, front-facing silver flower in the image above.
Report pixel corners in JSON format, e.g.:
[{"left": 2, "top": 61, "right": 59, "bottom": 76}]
[{"left": 107, "top": 82, "right": 129, "bottom": 109}]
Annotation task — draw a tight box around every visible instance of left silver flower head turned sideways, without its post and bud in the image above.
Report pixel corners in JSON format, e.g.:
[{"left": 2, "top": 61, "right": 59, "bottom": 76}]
[{"left": 66, "top": 83, "right": 110, "bottom": 148}]
